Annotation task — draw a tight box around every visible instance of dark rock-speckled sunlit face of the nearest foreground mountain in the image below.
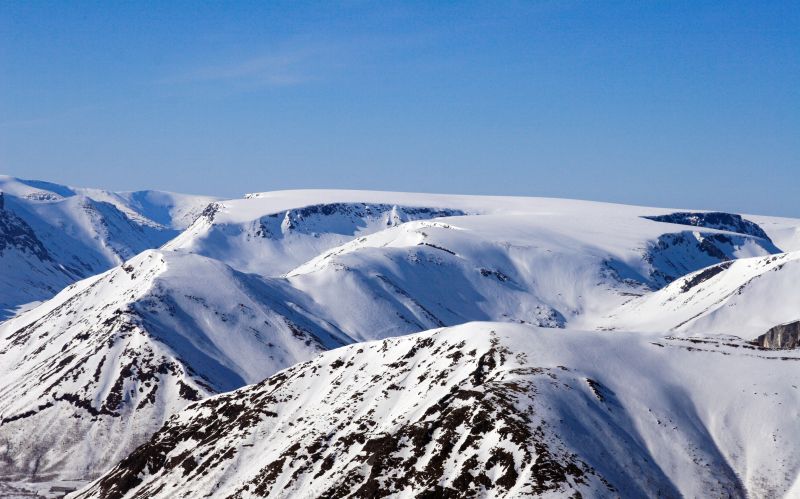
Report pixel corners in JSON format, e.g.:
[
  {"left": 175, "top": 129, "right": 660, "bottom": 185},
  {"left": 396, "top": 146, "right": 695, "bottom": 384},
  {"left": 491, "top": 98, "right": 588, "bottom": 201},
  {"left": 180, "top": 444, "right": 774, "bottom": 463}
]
[{"left": 79, "top": 333, "right": 616, "bottom": 499}]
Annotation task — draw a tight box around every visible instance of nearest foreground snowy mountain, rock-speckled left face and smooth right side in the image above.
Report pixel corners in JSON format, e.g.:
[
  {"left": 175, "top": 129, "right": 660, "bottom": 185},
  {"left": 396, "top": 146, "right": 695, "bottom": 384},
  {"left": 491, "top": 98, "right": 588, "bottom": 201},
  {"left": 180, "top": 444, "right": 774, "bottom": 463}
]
[{"left": 78, "top": 323, "right": 800, "bottom": 498}]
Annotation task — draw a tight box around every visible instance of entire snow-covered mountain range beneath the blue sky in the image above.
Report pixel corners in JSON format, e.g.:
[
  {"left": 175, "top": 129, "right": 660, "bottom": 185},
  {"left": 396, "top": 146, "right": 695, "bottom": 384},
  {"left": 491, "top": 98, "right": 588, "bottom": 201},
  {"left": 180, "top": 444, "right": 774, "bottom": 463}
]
[{"left": 0, "top": 177, "right": 800, "bottom": 497}]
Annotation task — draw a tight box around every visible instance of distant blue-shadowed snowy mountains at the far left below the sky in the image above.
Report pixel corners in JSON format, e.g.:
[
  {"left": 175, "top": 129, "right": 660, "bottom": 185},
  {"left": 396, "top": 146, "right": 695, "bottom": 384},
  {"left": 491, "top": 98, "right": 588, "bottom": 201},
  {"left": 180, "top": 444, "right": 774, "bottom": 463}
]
[{"left": 0, "top": 176, "right": 213, "bottom": 320}]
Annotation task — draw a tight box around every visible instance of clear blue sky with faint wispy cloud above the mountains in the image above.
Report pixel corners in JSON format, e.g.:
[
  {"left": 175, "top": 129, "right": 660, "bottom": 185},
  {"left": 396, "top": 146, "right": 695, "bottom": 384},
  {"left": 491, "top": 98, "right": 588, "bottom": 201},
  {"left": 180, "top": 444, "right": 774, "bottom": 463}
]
[{"left": 0, "top": 0, "right": 800, "bottom": 216}]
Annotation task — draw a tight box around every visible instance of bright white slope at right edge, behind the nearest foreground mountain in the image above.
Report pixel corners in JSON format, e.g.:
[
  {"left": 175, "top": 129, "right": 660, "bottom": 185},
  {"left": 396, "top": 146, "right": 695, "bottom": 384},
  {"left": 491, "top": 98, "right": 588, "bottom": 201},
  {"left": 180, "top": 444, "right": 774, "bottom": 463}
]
[{"left": 599, "top": 251, "right": 800, "bottom": 339}]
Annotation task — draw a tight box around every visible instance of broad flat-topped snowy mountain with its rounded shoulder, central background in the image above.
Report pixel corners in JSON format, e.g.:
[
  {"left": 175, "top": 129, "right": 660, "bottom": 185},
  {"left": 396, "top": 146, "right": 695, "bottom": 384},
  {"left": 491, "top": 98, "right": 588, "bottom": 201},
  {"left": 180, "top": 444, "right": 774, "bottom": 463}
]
[{"left": 165, "top": 191, "right": 779, "bottom": 340}]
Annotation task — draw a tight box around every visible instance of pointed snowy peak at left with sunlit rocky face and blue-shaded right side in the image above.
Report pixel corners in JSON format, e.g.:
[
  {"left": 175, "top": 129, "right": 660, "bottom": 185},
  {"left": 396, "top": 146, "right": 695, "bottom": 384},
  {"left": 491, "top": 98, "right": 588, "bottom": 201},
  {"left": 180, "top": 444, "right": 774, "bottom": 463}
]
[{"left": 0, "top": 250, "right": 344, "bottom": 479}]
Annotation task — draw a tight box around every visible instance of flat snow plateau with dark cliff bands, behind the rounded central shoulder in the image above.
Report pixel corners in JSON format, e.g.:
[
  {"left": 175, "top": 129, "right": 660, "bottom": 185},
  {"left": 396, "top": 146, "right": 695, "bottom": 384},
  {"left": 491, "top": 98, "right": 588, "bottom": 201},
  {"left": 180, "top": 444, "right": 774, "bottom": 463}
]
[{"left": 167, "top": 190, "right": 780, "bottom": 284}]
